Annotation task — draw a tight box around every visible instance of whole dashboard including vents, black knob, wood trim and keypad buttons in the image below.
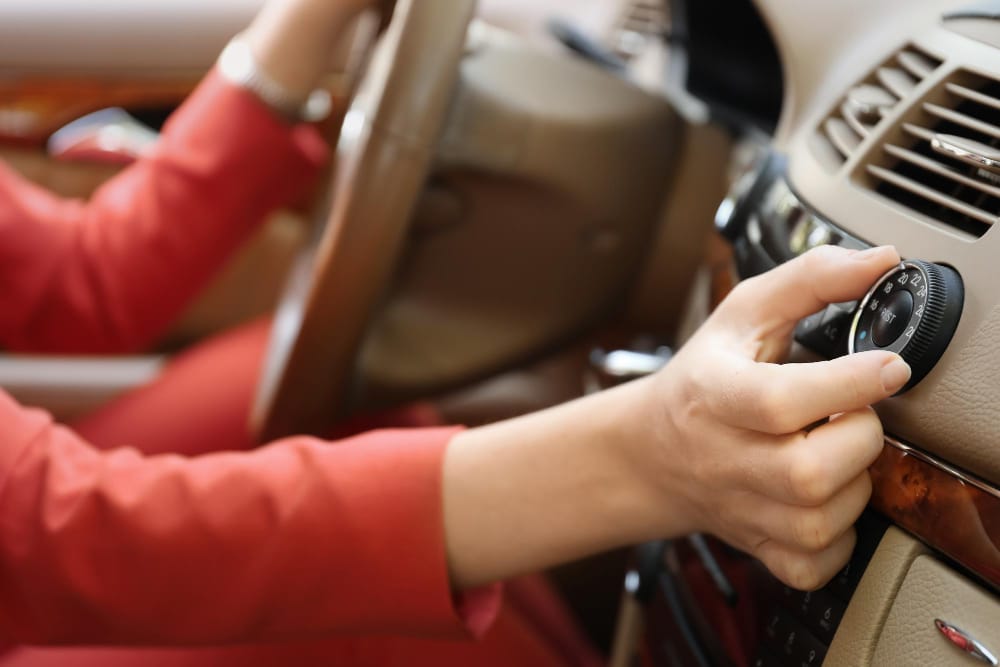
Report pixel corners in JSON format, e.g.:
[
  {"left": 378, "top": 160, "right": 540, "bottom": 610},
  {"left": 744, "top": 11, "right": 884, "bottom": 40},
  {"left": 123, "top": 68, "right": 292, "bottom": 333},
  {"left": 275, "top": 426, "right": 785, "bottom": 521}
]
[{"left": 628, "top": 0, "right": 1000, "bottom": 667}]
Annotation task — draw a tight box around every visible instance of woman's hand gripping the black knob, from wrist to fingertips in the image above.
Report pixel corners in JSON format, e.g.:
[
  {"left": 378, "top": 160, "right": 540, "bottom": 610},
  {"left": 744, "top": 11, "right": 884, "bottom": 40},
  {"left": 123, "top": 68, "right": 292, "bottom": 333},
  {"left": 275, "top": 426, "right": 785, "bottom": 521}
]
[{"left": 646, "top": 246, "right": 910, "bottom": 589}]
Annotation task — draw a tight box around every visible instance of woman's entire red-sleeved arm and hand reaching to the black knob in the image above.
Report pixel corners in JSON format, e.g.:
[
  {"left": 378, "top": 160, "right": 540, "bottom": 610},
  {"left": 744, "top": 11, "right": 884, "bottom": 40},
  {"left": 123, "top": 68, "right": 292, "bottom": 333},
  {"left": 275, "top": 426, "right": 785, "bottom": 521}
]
[{"left": 0, "top": 248, "right": 909, "bottom": 645}]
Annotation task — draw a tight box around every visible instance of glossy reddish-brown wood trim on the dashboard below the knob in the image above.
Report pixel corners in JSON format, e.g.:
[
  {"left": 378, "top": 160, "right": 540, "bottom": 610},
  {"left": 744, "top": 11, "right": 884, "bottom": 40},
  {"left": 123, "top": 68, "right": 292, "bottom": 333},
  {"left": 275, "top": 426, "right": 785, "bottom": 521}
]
[{"left": 871, "top": 438, "right": 1000, "bottom": 588}]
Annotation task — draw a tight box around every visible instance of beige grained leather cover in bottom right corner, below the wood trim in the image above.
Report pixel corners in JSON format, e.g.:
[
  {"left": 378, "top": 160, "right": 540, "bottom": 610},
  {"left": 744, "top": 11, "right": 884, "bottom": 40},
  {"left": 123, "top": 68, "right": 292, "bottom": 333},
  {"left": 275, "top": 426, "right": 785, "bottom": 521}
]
[{"left": 873, "top": 556, "right": 1000, "bottom": 667}]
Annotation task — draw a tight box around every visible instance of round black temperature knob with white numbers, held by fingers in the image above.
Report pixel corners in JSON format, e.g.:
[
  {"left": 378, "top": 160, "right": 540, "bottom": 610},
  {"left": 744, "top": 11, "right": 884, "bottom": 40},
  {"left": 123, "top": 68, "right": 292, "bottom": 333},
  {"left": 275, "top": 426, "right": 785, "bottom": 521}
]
[{"left": 848, "top": 260, "right": 965, "bottom": 393}]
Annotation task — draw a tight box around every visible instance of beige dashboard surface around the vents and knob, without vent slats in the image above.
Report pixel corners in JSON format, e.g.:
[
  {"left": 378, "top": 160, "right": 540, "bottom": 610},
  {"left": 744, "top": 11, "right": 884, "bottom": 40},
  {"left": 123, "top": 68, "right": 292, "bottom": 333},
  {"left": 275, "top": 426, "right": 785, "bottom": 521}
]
[{"left": 758, "top": 0, "right": 1000, "bottom": 482}]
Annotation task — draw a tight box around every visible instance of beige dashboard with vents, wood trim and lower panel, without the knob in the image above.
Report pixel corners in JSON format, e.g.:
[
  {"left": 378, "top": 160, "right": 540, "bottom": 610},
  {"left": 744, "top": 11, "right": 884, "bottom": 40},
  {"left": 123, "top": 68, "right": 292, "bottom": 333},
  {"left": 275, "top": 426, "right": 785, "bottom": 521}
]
[{"left": 704, "top": 0, "right": 1000, "bottom": 666}]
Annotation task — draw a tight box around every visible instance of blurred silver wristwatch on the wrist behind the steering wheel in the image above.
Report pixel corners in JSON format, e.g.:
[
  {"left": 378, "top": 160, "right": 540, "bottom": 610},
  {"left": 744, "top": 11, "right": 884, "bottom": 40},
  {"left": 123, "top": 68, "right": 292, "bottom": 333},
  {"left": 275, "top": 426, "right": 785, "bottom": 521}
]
[{"left": 218, "top": 35, "right": 332, "bottom": 123}]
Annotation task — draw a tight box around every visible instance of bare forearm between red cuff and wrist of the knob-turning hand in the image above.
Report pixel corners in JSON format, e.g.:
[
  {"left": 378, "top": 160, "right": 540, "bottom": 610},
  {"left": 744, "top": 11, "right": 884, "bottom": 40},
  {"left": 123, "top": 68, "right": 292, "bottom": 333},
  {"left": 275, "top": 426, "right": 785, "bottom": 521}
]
[{"left": 444, "top": 381, "right": 672, "bottom": 588}]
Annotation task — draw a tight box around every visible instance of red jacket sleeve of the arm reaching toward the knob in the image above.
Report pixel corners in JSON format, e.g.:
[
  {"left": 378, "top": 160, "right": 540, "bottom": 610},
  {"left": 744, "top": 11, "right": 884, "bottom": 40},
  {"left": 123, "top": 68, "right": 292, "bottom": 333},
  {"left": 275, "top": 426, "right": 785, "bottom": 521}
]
[{"left": 0, "top": 392, "right": 499, "bottom": 645}]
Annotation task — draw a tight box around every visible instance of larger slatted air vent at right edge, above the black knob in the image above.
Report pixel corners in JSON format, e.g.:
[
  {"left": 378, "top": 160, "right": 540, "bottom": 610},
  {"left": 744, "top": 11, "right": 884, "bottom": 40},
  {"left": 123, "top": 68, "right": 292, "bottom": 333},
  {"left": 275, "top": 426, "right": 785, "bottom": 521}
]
[{"left": 866, "top": 72, "right": 1000, "bottom": 238}]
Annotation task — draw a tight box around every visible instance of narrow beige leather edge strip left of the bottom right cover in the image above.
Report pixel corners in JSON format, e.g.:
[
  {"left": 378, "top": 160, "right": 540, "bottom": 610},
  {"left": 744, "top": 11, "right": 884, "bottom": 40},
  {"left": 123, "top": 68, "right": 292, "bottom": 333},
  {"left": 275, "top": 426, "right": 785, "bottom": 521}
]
[{"left": 823, "top": 527, "right": 926, "bottom": 667}]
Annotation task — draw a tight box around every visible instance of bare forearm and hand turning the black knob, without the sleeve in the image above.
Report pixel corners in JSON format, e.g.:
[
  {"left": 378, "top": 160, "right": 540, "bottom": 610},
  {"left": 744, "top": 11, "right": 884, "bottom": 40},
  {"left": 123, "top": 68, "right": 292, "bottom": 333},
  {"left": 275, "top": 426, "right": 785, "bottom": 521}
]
[{"left": 444, "top": 247, "right": 910, "bottom": 589}]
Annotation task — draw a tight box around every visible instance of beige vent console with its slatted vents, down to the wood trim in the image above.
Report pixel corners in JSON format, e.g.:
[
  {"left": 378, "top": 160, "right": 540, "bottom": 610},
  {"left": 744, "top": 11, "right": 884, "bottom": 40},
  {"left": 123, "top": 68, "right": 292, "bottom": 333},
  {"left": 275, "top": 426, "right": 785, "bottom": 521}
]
[{"left": 785, "top": 3, "right": 1000, "bottom": 483}]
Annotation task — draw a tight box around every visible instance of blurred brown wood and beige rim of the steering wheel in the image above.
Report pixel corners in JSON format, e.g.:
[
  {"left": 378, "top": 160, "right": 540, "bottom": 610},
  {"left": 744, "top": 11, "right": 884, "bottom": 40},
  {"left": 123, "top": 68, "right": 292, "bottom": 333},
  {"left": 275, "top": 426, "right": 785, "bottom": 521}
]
[{"left": 250, "top": 0, "right": 475, "bottom": 442}]
